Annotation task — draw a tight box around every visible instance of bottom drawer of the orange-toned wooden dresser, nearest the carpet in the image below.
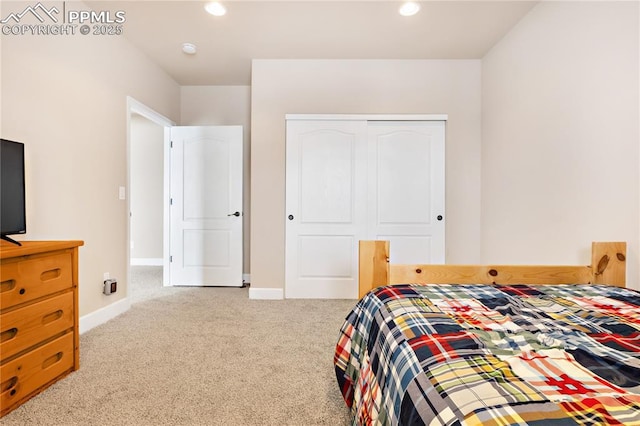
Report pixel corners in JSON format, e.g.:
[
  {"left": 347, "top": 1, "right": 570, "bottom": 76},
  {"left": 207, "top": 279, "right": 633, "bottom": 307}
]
[{"left": 0, "top": 333, "right": 74, "bottom": 414}]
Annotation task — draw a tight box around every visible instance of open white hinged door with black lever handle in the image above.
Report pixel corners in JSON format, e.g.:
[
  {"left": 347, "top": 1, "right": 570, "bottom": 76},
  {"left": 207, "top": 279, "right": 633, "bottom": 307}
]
[{"left": 170, "top": 126, "right": 242, "bottom": 287}]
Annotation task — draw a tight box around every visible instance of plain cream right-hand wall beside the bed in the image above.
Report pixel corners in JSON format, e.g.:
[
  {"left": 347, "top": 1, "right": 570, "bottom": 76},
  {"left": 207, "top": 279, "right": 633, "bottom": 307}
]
[{"left": 482, "top": 2, "right": 640, "bottom": 288}]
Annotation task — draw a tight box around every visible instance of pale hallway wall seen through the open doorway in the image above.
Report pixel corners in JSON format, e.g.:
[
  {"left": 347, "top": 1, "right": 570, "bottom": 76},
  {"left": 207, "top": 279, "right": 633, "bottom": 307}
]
[{"left": 129, "top": 114, "right": 164, "bottom": 264}]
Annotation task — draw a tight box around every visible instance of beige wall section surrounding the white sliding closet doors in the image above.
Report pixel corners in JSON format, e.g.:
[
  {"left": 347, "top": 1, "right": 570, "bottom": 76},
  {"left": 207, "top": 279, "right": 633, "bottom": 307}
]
[{"left": 251, "top": 60, "right": 481, "bottom": 289}]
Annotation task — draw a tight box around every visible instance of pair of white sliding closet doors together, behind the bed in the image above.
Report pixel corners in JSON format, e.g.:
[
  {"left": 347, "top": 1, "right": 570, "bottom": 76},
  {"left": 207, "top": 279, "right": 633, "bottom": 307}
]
[{"left": 285, "top": 118, "right": 445, "bottom": 298}]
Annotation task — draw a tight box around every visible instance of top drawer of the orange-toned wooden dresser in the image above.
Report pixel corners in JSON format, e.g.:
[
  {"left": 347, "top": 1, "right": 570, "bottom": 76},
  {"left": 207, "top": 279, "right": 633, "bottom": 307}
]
[{"left": 0, "top": 252, "right": 73, "bottom": 310}]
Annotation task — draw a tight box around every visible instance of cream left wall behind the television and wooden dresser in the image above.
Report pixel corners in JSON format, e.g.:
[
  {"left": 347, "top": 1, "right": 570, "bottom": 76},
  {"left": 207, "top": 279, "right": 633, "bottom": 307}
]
[{"left": 0, "top": 2, "right": 180, "bottom": 316}]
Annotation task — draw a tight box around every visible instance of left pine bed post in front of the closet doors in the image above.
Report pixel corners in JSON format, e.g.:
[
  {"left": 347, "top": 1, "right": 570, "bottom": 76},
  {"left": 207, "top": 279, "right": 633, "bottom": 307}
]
[{"left": 358, "top": 241, "right": 389, "bottom": 298}]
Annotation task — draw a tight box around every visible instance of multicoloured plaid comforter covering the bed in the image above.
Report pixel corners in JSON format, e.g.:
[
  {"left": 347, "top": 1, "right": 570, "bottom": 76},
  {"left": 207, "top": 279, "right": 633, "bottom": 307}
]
[{"left": 334, "top": 285, "right": 640, "bottom": 426}]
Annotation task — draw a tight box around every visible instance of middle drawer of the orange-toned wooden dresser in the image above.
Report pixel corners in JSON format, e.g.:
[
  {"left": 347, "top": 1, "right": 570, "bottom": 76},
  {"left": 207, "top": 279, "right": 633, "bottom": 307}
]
[{"left": 0, "top": 292, "right": 74, "bottom": 360}]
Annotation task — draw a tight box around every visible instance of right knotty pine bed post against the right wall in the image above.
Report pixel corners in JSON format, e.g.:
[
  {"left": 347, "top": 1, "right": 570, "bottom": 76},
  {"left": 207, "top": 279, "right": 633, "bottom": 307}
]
[{"left": 591, "top": 242, "right": 627, "bottom": 287}]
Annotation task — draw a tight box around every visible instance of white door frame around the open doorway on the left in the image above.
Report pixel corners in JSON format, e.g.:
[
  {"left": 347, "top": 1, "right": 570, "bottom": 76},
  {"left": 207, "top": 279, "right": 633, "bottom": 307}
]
[{"left": 126, "top": 96, "right": 176, "bottom": 286}]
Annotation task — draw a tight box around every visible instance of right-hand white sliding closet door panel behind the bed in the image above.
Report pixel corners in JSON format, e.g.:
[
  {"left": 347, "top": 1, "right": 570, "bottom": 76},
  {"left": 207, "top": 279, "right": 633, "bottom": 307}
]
[{"left": 367, "top": 121, "right": 445, "bottom": 264}]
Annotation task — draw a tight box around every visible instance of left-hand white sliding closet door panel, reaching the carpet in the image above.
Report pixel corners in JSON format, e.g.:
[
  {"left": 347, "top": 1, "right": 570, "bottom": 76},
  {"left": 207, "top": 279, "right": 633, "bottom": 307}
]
[{"left": 285, "top": 120, "right": 367, "bottom": 299}]
